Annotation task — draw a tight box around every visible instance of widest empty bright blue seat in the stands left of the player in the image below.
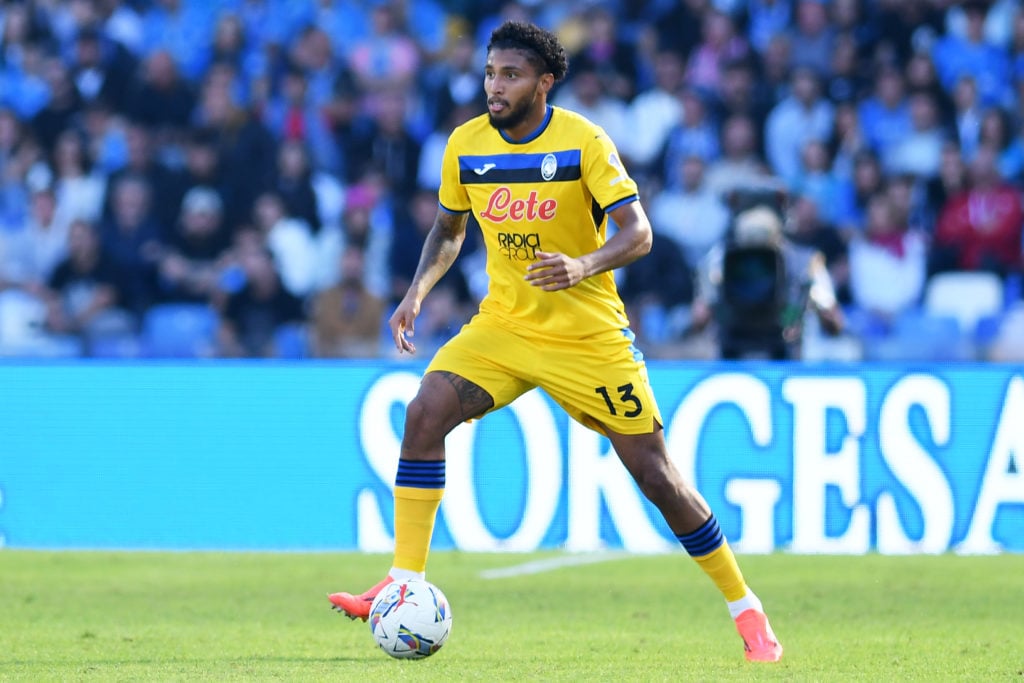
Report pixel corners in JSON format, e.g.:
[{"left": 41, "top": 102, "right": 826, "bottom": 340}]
[{"left": 142, "top": 303, "right": 218, "bottom": 358}]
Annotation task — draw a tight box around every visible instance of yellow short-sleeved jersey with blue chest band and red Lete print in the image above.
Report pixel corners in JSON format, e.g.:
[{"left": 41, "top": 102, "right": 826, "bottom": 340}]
[{"left": 438, "top": 105, "right": 638, "bottom": 339}]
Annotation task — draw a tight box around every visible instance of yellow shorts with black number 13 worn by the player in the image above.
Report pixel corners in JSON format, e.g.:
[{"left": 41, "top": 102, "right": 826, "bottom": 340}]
[{"left": 427, "top": 314, "right": 663, "bottom": 434}]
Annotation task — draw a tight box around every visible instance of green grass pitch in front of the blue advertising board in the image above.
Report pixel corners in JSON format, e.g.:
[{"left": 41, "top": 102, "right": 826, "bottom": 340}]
[{"left": 0, "top": 550, "right": 1024, "bottom": 683}]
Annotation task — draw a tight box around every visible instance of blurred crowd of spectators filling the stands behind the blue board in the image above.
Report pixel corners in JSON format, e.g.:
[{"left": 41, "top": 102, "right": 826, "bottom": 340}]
[{"left": 0, "top": 0, "right": 1024, "bottom": 359}]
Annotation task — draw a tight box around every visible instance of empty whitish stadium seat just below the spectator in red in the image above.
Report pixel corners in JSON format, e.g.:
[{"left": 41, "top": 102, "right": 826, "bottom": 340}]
[{"left": 924, "top": 271, "right": 1004, "bottom": 335}]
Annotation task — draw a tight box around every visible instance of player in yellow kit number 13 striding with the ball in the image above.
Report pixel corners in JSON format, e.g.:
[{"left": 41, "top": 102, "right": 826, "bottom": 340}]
[{"left": 329, "top": 23, "right": 782, "bottom": 661}]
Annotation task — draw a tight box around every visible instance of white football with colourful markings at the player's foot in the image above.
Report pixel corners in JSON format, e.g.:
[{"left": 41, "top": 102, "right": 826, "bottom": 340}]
[{"left": 369, "top": 579, "right": 452, "bottom": 659}]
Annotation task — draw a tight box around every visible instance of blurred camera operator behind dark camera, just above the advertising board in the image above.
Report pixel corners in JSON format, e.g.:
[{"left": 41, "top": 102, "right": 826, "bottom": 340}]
[{"left": 692, "top": 189, "right": 843, "bottom": 360}]
